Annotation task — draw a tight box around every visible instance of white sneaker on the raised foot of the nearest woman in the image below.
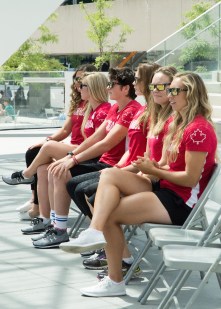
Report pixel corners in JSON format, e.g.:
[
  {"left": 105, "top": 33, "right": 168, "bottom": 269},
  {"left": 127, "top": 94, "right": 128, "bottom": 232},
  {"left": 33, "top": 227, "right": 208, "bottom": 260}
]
[{"left": 60, "top": 228, "right": 106, "bottom": 253}]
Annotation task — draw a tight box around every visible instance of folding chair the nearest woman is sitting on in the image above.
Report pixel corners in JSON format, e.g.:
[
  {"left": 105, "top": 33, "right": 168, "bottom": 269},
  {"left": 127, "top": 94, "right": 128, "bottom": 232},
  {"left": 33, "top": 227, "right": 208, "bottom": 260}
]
[{"left": 125, "top": 164, "right": 221, "bottom": 284}]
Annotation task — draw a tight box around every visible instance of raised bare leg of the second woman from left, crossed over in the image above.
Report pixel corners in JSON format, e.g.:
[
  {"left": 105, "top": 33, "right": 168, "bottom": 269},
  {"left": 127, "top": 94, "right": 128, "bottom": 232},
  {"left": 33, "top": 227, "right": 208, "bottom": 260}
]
[{"left": 23, "top": 141, "right": 75, "bottom": 178}]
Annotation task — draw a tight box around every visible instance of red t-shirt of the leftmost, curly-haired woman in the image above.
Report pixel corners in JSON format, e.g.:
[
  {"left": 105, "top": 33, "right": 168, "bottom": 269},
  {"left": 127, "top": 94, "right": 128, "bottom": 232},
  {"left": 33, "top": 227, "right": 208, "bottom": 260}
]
[{"left": 71, "top": 101, "right": 86, "bottom": 145}]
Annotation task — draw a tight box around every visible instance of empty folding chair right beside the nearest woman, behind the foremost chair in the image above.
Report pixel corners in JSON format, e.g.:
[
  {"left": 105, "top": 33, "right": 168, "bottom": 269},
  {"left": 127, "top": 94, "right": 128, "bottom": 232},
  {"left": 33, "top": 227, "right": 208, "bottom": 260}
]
[{"left": 138, "top": 165, "right": 221, "bottom": 308}]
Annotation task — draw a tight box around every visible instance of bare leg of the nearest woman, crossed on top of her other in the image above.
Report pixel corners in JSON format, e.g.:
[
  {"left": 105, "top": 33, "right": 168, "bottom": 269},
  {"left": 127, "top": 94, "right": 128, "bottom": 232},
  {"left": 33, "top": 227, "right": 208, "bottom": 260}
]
[{"left": 90, "top": 169, "right": 152, "bottom": 231}]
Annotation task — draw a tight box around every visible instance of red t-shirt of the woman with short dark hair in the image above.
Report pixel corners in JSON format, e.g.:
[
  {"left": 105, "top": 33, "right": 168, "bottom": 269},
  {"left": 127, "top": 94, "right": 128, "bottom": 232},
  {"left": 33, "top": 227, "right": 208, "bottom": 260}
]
[{"left": 100, "top": 100, "right": 141, "bottom": 166}]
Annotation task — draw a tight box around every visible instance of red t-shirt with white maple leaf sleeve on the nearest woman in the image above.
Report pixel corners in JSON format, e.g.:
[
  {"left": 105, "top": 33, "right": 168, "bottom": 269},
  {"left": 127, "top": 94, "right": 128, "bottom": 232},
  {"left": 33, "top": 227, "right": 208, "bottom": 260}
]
[{"left": 160, "top": 115, "right": 217, "bottom": 208}]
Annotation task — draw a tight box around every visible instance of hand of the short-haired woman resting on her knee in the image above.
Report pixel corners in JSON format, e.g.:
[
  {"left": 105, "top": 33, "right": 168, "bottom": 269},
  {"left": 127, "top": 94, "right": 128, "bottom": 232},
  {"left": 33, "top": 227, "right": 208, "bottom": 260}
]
[{"left": 48, "top": 156, "right": 75, "bottom": 178}]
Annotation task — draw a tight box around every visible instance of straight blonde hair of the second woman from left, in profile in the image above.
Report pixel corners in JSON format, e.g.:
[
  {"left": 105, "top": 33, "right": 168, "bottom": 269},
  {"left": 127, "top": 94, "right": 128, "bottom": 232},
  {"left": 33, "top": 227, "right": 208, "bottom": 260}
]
[{"left": 81, "top": 72, "right": 108, "bottom": 138}]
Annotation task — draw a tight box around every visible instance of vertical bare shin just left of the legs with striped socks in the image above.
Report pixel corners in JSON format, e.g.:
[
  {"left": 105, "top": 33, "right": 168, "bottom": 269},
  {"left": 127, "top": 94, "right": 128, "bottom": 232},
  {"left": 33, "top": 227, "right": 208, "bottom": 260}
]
[{"left": 37, "top": 164, "right": 50, "bottom": 218}]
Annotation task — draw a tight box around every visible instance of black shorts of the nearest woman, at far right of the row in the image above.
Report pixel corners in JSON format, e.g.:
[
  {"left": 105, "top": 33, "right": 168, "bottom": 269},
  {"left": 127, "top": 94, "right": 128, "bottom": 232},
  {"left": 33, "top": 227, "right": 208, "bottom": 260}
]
[{"left": 152, "top": 182, "right": 192, "bottom": 225}]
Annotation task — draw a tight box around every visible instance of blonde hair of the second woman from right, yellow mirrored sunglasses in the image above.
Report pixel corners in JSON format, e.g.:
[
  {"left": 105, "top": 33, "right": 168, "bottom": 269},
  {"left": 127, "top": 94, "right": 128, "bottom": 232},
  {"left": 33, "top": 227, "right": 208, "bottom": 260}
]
[{"left": 148, "top": 66, "right": 177, "bottom": 136}]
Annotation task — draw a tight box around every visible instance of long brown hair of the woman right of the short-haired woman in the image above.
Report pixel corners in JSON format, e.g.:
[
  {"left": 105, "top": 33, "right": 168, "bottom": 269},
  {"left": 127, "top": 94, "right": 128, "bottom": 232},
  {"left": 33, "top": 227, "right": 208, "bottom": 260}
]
[{"left": 137, "top": 63, "right": 160, "bottom": 130}]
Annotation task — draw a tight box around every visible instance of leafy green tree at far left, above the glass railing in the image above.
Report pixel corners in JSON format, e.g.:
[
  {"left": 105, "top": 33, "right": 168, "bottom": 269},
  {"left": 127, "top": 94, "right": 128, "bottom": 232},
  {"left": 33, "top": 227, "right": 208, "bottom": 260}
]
[{"left": 1, "top": 14, "right": 65, "bottom": 71}]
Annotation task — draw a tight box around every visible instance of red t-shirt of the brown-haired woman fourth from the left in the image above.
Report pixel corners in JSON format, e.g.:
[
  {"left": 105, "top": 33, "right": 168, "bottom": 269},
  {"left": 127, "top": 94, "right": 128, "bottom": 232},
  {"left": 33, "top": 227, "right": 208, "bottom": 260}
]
[{"left": 119, "top": 106, "right": 147, "bottom": 167}]
